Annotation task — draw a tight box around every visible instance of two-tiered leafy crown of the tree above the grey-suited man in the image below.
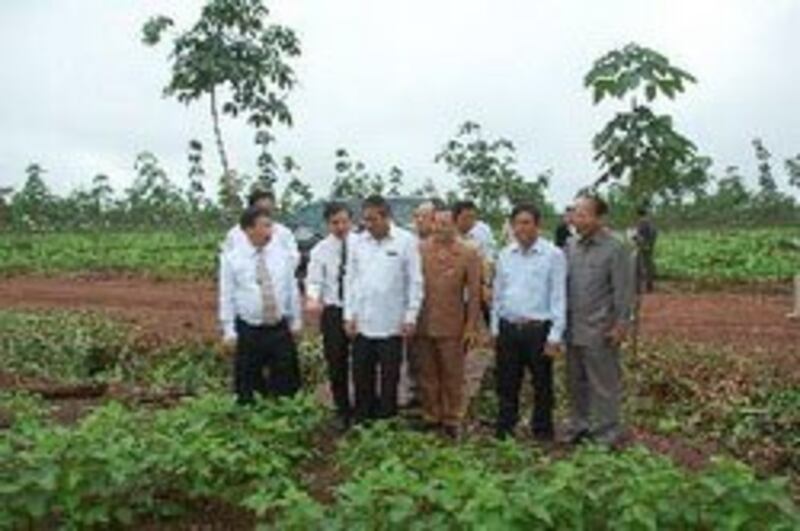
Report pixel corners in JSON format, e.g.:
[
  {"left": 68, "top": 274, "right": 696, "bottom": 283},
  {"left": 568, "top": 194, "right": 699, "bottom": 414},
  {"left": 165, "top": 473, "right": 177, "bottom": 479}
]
[{"left": 584, "top": 44, "right": 697, "bottom": 208}]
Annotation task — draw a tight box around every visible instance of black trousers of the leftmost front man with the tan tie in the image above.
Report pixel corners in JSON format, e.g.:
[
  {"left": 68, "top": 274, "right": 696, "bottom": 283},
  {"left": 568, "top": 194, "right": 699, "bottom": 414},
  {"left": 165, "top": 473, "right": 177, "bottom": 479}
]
[{"left": 238, "top": 319, "right": 300, "bottom": 404}]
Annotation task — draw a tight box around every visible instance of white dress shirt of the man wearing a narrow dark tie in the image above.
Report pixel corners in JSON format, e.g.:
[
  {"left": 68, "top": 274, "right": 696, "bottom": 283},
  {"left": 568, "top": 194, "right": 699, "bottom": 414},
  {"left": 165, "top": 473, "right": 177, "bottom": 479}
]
[{"left": 306, "top": 232, "right": 357, "bottom": 308}]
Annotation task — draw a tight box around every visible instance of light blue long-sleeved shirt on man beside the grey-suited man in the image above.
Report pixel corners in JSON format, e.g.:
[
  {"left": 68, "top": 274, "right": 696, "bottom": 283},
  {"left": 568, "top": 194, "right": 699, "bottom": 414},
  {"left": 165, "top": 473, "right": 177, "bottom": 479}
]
[{"left": 492, "top": 238, "right": 567, "bottom": 343}]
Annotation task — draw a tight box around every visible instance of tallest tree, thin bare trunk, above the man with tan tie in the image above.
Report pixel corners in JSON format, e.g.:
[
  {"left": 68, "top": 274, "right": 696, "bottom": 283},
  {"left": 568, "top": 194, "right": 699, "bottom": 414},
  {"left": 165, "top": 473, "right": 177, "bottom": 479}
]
[{"left": 142, "top": 0, "right": 300, "bottom": 214}]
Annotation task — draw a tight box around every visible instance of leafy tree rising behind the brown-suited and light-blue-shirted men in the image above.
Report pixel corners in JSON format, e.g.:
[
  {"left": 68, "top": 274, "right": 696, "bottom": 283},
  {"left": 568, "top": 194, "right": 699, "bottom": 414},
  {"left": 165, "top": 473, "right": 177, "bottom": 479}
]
[{"left": 435, "top": 121, "right": 552, "bottom": 226}]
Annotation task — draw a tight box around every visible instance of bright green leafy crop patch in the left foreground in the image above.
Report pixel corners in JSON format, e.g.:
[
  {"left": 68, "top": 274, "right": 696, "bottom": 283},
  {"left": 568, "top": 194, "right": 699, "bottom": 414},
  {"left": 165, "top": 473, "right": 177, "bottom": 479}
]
[{"left": 0, "top": 395, "right": 321, "bottom": 529}]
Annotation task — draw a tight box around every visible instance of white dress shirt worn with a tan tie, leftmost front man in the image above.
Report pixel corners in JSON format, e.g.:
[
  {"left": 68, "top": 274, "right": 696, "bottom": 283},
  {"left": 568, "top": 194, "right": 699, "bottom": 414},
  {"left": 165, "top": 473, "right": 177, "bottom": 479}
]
[{"left": 219, "top": 239, "right": 302, "bottom": 340}]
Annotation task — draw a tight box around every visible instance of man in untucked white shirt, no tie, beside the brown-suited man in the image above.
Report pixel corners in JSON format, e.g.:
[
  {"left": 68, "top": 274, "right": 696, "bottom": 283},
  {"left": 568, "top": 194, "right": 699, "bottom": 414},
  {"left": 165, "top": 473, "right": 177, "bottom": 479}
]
[{"left": 344, "top": 196, "right": 423, "bottom": 422}]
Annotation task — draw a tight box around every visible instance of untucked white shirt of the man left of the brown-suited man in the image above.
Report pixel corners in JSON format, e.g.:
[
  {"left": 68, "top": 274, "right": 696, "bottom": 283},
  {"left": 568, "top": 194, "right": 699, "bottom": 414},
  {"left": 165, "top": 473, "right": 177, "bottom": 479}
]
[{"left": 344, "top": 225, "right": 423, "bottom": 339}]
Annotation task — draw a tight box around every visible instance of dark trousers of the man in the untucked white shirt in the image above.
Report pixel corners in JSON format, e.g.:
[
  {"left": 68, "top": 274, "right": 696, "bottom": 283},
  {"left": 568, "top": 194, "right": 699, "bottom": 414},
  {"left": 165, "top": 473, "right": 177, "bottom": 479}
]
[{"left": 353, "top": 335, "right": 403, "bottom": 422}]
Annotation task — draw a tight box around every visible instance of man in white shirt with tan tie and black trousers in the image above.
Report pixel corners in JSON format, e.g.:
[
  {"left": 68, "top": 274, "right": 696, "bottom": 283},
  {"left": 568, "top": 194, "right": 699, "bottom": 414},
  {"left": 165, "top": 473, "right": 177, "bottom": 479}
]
[{"left": 219, "top": 206, "right": 302, "bottom": 404}]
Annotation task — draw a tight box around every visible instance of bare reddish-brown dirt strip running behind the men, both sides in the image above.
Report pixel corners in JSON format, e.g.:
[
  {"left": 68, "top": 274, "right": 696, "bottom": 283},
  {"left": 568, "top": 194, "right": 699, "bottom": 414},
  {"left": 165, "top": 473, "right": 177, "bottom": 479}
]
[{"left": 0, "top": 277, "right": 800, "bottom": 351}]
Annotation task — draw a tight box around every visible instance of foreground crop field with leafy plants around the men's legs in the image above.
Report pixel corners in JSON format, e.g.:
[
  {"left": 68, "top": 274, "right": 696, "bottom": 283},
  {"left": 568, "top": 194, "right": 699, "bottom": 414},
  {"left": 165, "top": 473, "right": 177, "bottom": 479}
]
[{"left": 0, "top": 310, "right": 800, "bottom": 530}]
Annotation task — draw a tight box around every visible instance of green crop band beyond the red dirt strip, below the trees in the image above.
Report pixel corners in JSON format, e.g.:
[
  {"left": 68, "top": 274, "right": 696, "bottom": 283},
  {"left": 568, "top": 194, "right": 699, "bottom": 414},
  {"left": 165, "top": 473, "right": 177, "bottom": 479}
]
[{"left": 0, "top": 228, "right": 800, "bottom": 283}]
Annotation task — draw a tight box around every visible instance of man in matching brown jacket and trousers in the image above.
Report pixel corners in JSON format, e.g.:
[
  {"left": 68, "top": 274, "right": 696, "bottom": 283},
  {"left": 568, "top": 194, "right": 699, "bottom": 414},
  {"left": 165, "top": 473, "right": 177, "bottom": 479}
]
[{"left": 414, "top": 202, "right": 481, "bottom": 438}]
